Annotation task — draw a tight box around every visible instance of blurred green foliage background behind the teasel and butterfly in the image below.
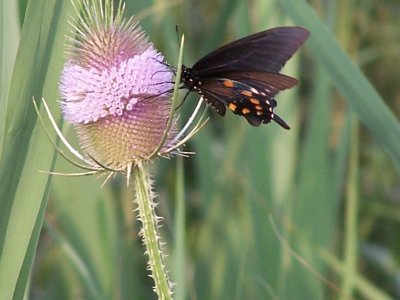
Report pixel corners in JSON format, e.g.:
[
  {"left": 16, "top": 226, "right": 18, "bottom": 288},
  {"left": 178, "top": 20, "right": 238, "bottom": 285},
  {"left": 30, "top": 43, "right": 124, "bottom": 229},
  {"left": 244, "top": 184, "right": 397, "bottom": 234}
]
[{"left": 0, "top": 0, "right": 400, "bottom": 300}]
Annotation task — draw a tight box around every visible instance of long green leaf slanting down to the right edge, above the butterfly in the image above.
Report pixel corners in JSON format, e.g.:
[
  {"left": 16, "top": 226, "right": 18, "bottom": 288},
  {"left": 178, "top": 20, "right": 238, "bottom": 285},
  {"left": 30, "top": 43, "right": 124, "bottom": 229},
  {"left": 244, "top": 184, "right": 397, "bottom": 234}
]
[{"left": 280, "top": 0, "right": 400, "bottom": 169}]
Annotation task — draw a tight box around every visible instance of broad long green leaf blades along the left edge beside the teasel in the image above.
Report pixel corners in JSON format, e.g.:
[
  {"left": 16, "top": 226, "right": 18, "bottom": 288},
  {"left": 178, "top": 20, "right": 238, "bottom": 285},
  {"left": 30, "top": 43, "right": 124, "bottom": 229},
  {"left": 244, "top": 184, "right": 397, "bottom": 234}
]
[{"left": 0, "top": 0, "right": 70, "bottom": 299}]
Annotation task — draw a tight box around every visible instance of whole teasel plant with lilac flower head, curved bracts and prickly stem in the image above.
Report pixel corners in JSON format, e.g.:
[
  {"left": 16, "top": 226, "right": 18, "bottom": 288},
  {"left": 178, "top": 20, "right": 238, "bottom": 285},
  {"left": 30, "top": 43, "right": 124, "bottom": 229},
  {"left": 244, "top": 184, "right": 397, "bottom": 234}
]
[{"left": 34, "top": 0, "right": 207, "bottom": 300}]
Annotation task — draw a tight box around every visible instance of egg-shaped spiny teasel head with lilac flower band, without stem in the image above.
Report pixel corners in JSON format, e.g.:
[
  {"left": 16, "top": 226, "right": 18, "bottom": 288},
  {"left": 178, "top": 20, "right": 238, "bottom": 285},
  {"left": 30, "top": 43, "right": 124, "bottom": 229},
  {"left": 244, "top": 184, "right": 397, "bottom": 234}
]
[{"left": 60, "top": 0, "right": 188, "bottom": 171}]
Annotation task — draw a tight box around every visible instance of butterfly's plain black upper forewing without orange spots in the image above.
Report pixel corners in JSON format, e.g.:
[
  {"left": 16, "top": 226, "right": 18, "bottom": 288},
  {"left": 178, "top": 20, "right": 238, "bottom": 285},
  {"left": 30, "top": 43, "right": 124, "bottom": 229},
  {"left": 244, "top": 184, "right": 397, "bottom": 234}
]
[{"left": 192, "top": 27, "right": 309, "bottom": 79}]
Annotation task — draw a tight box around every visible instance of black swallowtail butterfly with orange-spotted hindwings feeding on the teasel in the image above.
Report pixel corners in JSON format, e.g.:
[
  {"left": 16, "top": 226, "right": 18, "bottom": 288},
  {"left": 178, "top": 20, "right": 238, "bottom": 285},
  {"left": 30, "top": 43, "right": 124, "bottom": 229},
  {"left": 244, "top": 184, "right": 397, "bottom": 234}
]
[{"left": 181, "top": 27, "right": 309, "bottom": 129}]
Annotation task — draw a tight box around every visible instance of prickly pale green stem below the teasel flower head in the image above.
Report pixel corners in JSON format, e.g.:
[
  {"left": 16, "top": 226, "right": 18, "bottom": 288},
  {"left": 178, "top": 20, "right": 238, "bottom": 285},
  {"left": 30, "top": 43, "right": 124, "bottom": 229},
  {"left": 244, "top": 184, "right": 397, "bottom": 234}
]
[{"left": 133, "top": 163, "right": 172, "bottom": 300}]
